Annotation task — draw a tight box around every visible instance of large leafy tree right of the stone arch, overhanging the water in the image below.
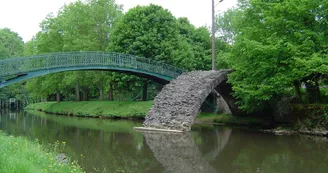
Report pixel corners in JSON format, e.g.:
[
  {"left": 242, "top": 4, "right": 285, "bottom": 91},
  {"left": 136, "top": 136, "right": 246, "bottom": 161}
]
[{"left": 220, "top": 0, "right": 328, "bottom": 112}]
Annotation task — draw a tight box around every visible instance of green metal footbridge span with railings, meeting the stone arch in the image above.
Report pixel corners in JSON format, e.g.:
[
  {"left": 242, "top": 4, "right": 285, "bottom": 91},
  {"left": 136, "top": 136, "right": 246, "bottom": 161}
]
[{"left": 0, "top": 52, "right": 184, "bottom": 88}]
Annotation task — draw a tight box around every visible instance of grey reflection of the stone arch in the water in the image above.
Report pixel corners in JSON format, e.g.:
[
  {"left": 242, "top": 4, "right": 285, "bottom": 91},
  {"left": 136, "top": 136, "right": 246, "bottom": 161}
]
[{"left": 143, "top": 132, "right": 216, "bottom": 173}]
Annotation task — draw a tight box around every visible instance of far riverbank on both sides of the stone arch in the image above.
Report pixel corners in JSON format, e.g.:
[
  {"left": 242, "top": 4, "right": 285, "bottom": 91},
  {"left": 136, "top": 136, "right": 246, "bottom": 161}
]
[{"left": 25, "top": 101, "right": 328, "bottom": 136}]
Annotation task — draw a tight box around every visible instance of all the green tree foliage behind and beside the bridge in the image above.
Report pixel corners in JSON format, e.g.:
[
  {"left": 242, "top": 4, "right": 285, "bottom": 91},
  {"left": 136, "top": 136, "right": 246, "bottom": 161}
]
[{"left": 0, "top": 0, "right": 328, "bottom": 116}]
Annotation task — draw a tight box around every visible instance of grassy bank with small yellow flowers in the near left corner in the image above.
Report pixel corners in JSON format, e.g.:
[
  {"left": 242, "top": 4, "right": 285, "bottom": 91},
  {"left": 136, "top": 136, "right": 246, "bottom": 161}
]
[{"left": 0, "top": 131, "right": 82, "bottom": 173}]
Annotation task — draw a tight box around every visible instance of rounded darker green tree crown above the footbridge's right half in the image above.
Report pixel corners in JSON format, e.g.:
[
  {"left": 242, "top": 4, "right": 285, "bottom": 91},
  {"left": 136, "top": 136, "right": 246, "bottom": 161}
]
[{"left": 108, "top": 4, "right": 181, "bottom": 64}]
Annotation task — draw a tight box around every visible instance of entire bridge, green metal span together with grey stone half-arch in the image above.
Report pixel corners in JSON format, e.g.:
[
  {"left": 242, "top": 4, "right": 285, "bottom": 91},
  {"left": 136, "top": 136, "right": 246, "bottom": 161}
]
[{"left": 0, "top": 52, "right": 236, "bottom": 131}]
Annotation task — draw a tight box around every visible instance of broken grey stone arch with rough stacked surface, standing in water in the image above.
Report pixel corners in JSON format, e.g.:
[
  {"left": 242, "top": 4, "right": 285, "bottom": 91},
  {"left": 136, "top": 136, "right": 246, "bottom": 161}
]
[{"left": 140, "top": 70, "right": 235, "bottom": 131}]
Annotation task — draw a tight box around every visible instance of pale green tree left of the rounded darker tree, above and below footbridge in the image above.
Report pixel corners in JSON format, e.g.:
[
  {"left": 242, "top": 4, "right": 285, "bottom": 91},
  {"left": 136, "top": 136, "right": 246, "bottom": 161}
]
[{"left": 25, "top": 0, "right": 122, "bottom": 100}]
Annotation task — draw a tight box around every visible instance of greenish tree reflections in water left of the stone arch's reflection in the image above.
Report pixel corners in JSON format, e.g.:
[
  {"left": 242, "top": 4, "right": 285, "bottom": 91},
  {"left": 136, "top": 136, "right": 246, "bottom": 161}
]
[{"left": 0, "top": 111, "right": 163, "bottom": 173}]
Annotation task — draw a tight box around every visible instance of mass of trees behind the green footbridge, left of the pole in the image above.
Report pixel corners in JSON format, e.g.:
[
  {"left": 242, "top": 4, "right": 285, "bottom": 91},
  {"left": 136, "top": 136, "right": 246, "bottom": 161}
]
[{"left": 0, "top": 0, "right": 211, "bottom": 104}]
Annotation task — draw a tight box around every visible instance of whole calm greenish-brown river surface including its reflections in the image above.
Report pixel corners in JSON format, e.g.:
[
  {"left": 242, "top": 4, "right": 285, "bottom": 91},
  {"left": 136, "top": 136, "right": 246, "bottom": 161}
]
[{"left": 0, "top": 110, "right": 328, "bottom": 173}]
